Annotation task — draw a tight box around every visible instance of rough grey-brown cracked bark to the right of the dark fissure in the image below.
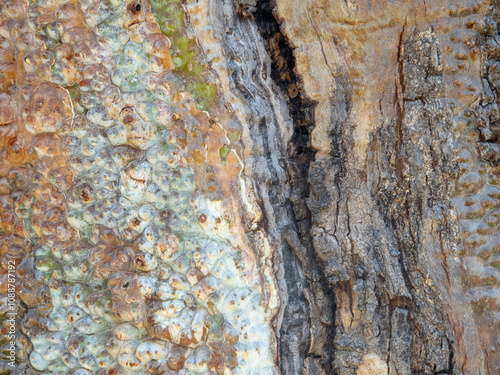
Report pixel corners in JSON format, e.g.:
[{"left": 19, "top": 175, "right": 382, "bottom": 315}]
[{"left": 277, "top": 1, "right": 498, "bottom": 374}]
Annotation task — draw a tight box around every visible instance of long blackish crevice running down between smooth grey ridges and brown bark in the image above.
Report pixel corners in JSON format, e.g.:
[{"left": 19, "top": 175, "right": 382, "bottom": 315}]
[{"left": 255, "top": 1, "right": 335, "bottom": 374}]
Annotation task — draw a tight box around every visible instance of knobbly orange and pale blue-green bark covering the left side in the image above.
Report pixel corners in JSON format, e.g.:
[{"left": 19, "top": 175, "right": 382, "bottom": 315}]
[{"left": 0, "top": 0, "right": 284, "bottom": 375}]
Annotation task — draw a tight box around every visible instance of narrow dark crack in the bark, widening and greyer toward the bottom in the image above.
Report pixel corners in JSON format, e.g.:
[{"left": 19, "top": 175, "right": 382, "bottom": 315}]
[{"left": 254, "top": 0, "right": 335, "bottom": 374}]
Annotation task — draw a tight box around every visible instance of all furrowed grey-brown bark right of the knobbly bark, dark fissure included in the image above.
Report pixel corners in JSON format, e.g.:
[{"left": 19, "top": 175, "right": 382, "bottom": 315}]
[{"left": 177, "top": 0, "right": 497, "bottom": 374}]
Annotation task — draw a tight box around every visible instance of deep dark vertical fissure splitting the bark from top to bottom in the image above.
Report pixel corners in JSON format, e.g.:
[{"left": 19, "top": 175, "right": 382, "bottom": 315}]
[{"left": 254, "top": 0, "right": 335, "bottom": 374}]
